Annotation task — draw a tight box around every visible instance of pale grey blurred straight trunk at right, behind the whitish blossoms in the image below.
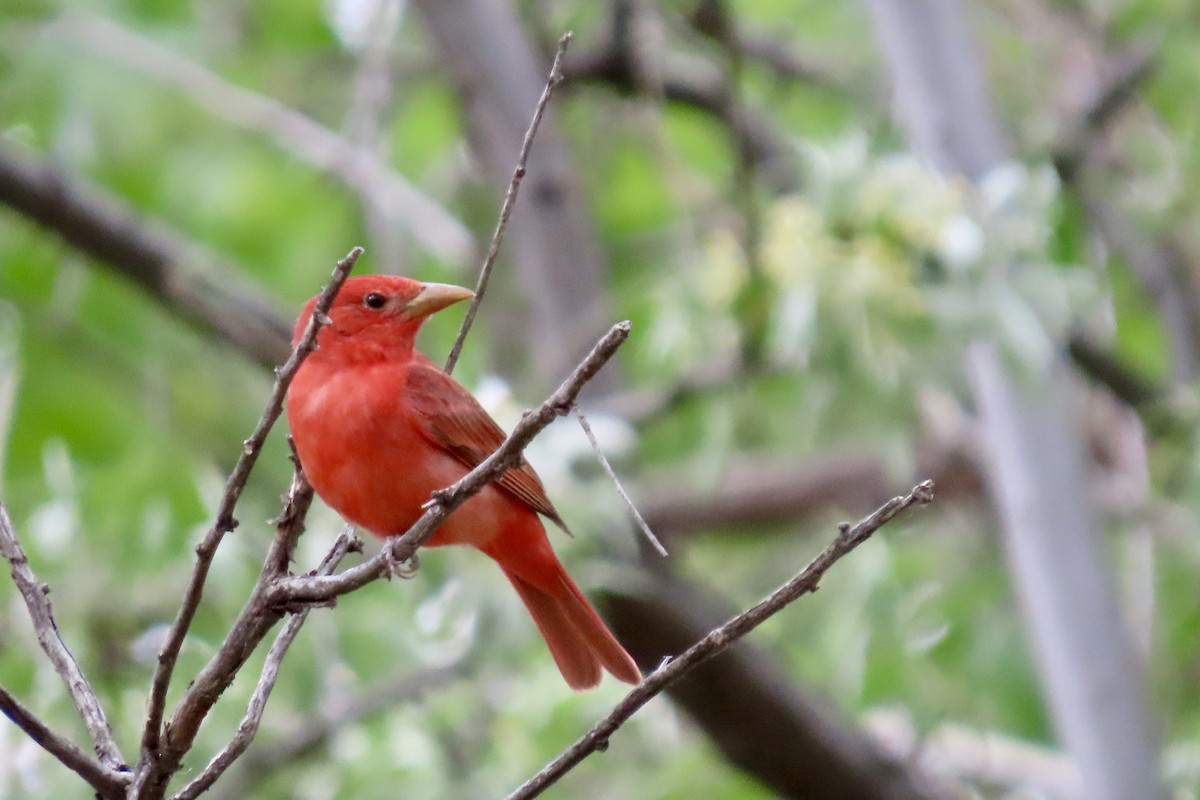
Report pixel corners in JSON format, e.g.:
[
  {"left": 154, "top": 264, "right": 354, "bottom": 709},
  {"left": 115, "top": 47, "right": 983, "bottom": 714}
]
[{"left": 870, "top": 0, "right": 1165, "bottom": 800}]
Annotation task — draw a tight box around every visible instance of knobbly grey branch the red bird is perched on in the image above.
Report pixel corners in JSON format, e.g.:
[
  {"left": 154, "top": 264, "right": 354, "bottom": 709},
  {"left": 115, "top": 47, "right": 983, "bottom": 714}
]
[{"left": 270, "top": 321, "right": 632, "bottom": 604}]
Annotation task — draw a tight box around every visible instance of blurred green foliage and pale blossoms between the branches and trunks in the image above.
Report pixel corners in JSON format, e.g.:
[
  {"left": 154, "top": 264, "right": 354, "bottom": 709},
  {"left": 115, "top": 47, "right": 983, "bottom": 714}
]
[{"left": 0, "top": 0, "right": 1200, "bottom": 800}]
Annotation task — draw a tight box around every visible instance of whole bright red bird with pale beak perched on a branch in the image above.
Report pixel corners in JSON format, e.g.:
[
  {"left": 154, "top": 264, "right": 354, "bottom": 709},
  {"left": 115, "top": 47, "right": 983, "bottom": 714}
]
[{"left": 288, "top": 275, "right": 641, "bottom": 690}]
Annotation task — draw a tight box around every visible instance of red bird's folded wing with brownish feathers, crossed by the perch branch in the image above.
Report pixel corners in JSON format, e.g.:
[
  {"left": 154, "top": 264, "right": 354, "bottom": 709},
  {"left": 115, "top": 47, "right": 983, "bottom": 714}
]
[{"left": 404, "top": 359, "right": 566, "bottom": 530}]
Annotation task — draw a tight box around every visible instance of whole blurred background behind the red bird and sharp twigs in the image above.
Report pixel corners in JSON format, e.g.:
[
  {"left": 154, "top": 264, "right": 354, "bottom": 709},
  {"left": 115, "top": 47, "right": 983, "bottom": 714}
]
[{"left": 0, "top": 0, "right": 1200, "bottom": 800}]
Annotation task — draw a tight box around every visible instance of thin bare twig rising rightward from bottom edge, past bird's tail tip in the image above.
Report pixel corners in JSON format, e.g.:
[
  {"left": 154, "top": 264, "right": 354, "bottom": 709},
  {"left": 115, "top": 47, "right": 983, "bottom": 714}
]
[{"left": 508, "top": 481, "right": 934, "bottom": 800}]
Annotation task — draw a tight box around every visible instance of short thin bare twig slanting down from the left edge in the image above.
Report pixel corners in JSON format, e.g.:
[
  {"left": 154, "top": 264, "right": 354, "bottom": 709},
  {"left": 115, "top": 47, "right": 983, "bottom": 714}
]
[{"left": 0, "top": 503, "right": 125, "bottom": 769}]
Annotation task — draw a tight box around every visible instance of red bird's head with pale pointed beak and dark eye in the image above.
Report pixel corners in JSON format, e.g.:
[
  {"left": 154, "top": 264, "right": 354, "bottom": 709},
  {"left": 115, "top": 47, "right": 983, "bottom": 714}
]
[{"left": 292, "top": 275, "right": 474, "bottom": 357}]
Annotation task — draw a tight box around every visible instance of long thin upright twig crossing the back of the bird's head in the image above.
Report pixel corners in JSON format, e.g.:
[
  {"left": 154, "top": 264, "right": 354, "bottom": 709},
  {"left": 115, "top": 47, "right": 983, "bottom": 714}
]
[{"left": 142, "top": 247, "right": 362, "bottom": 760}]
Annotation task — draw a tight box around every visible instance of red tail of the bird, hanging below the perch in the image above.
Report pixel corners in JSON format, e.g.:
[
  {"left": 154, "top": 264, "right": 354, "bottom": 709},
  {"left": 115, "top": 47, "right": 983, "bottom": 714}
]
[{"left": 488, "top": 525, "right": 642, "bottom": 690}]
